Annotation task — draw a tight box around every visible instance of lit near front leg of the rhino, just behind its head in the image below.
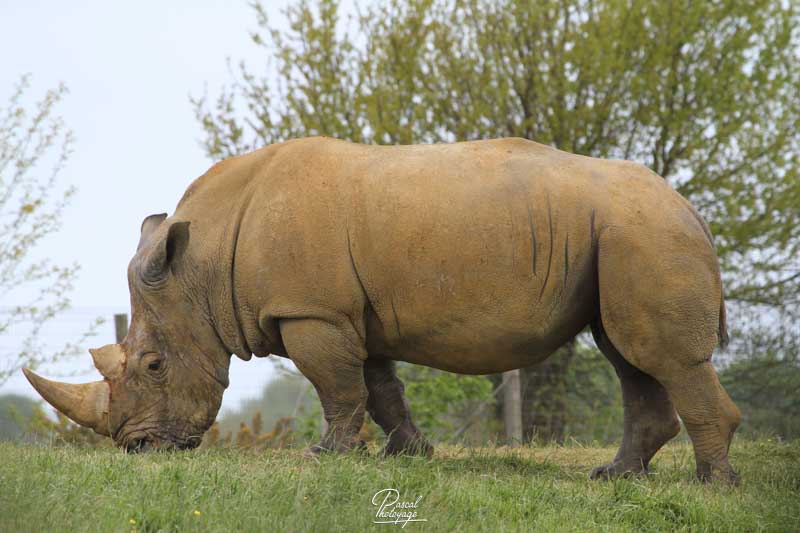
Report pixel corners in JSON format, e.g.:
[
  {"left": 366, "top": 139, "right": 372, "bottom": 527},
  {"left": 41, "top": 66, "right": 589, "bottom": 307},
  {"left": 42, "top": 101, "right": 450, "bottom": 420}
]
[{"left": 280, "top": 319, "right": 367, "bottom": 454}]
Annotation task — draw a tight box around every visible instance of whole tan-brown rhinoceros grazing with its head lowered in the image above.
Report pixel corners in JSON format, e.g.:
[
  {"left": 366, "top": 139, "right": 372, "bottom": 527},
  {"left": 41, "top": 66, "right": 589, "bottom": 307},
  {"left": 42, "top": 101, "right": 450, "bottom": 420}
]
[{"left": 25, "top": 137, "right": 740, "bottom": 482}]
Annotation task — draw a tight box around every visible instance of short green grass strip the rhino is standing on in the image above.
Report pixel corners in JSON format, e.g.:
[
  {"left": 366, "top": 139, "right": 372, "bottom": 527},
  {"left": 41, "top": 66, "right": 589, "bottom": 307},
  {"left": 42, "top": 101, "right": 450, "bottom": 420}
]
[{"left": 0, "top": 440, "right": 800, "bottom": 532}]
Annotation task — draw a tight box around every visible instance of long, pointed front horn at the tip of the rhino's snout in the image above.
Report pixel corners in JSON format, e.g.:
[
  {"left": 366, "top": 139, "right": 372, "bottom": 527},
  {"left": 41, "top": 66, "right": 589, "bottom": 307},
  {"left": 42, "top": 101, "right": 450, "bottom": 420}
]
[{"left": 22, "top": 368, "right": 111, "bottom": 437}]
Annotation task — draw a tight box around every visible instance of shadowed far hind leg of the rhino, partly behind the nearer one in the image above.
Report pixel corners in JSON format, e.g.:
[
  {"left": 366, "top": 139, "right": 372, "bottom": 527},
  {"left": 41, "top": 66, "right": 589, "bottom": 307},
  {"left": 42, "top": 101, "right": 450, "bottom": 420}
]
[{"left": 589, "top": 319, "right": 681, "bottom": 479}]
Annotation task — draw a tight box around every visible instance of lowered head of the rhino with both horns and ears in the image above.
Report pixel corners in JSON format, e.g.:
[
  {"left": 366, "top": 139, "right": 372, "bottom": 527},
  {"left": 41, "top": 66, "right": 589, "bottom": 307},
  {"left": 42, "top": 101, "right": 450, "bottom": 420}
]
[{"left": 23, "top": 214, "right": 230, "bottom": 451}]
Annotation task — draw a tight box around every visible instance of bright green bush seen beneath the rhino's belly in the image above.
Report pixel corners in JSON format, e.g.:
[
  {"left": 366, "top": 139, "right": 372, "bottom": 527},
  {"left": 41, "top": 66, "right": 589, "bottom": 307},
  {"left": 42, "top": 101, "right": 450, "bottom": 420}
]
[{"left": 397, "top": 363, "right": 494, "bottom": 443}]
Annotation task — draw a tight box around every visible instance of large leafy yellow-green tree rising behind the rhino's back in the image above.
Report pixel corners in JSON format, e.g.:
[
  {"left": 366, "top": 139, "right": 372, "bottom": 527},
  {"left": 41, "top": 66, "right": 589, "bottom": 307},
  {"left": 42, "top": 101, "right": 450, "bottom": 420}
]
[{"left": 193, "top": 0, "right": 800, "bottom": 440}]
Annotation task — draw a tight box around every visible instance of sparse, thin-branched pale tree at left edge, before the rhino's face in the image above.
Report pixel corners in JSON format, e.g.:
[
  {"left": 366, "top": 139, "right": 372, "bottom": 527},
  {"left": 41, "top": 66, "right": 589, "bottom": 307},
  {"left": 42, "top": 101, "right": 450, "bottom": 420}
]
[{"left": 0, "top": 76, "right": 100, "bottom": 384}]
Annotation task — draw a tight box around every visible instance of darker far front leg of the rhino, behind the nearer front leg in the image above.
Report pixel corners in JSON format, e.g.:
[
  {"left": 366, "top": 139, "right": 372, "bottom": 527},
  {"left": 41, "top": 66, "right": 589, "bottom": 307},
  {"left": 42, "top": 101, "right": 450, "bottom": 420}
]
[{"left": 364, "top": 358, "right": 433, "bottom": 457}]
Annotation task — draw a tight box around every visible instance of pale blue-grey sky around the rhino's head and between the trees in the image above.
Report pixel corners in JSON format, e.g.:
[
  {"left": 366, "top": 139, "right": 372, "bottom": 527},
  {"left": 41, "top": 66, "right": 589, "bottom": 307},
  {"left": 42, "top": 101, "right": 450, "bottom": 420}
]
[{"left": 0, "top": 0, "right": 318, "bottom": 409}]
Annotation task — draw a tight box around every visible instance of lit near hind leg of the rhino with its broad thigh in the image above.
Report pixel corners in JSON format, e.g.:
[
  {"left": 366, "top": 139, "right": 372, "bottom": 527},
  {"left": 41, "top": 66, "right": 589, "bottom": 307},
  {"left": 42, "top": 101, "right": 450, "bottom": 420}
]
[{"left": 597, "top": 227, "right": 741, "bottom": 484}]
